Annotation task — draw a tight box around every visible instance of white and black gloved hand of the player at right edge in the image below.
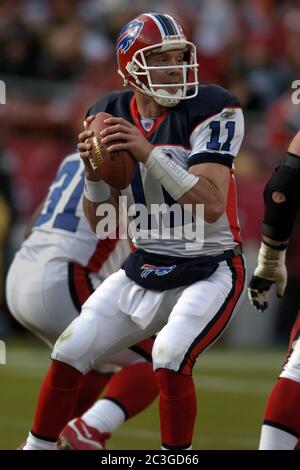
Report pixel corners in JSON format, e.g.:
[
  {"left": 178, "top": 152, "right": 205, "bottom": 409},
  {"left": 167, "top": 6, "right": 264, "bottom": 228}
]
[{"left": 248, "top": 242, "right": 287, "bottom": 312}]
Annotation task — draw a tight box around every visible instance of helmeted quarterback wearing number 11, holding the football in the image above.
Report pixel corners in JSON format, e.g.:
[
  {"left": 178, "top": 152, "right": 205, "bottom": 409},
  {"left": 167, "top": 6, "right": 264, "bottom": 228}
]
[{"left": 25, "top": 13, "right": 245, "bottom": 449}]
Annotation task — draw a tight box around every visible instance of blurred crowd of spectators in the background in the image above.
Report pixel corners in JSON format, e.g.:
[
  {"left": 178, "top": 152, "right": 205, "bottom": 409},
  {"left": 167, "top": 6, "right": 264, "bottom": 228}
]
[{"left": 0, "top": 0, "right": 300, "bottom": 336}]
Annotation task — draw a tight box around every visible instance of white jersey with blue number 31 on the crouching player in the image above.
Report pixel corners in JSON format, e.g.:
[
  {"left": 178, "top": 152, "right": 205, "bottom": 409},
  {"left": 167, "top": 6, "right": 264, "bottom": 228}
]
[{"left": 21, "top": 153, "right": 131, "bottom": 279}]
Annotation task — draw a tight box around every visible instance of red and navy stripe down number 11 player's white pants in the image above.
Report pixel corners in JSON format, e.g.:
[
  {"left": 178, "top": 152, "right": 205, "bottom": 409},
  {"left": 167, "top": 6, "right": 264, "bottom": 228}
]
[{"left": 178, "top": 256, "right": 245, "bottom": 375}]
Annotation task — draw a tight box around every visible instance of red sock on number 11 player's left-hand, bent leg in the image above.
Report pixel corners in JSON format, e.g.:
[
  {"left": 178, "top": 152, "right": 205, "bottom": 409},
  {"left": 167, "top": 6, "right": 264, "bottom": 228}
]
[{"left": 32, "top": 360, "right": 83, "bottom": 441}]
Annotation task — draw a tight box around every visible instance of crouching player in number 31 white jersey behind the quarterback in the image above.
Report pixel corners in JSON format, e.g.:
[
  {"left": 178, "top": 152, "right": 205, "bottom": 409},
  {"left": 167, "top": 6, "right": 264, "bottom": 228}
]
[{"left": 7, "top": 152, "right": 158, "bottom": 449}]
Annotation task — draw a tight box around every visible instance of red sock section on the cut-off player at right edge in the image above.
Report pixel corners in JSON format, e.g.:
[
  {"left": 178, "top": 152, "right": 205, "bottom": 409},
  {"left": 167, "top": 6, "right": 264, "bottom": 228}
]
[{"left": 264, "top": 377, "right": 300, "bottom": 436}]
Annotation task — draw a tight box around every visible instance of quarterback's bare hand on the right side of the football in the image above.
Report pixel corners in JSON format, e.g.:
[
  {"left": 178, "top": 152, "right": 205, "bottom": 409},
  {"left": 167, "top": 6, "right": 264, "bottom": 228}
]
[{"left": 101, "top": 117, "right": 154, "bottom": 163}]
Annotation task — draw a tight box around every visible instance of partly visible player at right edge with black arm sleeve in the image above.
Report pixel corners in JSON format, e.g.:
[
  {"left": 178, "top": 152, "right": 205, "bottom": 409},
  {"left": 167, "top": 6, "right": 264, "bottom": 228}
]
[{"left": 248, "top": 131, "right": 300, "bottom": 450}]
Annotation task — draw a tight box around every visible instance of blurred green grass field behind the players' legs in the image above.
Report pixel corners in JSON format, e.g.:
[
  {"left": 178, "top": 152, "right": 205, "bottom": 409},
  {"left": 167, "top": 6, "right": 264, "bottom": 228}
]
[{"left": 0, "top": 337, "right": 284, "bottom": 450}]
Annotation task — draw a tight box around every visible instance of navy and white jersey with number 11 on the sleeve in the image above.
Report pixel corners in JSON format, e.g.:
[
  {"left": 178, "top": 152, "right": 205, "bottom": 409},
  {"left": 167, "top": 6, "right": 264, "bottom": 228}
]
[{"left": 87, "top": 85, "right": 244, "bottom": 256}]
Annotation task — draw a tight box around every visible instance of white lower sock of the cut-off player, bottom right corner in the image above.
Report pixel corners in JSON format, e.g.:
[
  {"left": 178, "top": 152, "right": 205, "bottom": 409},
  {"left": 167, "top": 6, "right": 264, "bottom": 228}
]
[{"left": 259, "top": 424, "right": 298, "bottom": 450}]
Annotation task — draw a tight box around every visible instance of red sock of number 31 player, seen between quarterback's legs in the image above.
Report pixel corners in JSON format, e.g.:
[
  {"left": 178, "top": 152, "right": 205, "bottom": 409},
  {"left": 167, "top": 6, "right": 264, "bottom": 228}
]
[{"left": 103, "top": 362, "right": 158, "bottom": 419}]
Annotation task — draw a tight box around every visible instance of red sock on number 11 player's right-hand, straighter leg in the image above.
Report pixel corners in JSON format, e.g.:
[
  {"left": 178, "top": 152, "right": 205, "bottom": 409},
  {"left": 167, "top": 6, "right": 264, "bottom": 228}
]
[{"left": 156, "top": 369, "right": 197, "bottom": 449}]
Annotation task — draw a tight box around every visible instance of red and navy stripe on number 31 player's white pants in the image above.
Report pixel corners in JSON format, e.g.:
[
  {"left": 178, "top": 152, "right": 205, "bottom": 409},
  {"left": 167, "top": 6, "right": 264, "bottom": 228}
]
[{"left": 69, "top": 263, "right": 94, "bottom": 313}]
